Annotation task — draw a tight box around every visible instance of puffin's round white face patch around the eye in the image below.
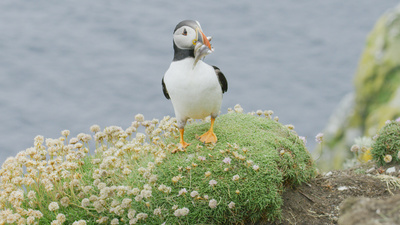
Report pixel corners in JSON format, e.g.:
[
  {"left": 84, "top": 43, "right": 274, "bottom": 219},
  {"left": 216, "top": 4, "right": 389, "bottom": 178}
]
[{"left": 174, "top": 26, "right": 198, "bottom": 49}]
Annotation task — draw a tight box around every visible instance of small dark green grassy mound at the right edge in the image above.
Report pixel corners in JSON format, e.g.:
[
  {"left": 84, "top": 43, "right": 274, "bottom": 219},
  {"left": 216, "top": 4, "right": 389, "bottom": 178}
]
[{"left": 371, "top": 121, "right": 400, "bottom": 166}]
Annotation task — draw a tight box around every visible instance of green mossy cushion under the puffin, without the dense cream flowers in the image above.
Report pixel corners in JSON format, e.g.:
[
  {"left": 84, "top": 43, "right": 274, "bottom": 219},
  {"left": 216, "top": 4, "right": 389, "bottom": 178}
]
[{"left": 156, "top": 113, "right": 315, "bottom": 224}]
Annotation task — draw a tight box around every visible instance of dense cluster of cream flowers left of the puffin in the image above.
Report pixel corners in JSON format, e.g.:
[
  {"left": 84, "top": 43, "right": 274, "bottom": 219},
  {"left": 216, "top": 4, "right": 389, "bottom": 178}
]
[{"left": 0, "top": 114, "right": 178, "bottom": 225}]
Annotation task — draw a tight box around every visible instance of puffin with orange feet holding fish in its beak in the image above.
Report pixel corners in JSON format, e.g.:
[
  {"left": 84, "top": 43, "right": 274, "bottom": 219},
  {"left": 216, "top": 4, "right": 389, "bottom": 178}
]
[{"left": 161, "top": 20, "right": 228, "bottom": 148}]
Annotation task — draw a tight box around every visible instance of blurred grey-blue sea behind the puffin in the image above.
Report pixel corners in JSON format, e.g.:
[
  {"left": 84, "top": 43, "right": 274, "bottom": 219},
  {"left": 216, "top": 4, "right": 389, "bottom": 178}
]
[{"left": 0, "top": 0, "right": 398, "bottom": 163}]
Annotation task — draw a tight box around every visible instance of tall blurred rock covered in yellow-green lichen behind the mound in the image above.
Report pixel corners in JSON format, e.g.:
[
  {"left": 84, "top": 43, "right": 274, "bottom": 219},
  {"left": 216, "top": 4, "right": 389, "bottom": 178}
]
[{"left": 320, "top": 5, "right": 400, "bottom": 170}]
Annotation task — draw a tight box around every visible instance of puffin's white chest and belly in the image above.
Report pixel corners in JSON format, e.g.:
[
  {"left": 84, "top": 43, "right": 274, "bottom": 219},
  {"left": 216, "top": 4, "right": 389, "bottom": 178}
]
[{"left": 164, "top": 58, "right": 222, "bottom": 120}]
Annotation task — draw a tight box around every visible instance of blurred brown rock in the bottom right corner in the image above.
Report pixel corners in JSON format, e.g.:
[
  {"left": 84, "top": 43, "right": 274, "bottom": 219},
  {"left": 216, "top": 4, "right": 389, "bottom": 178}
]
[{"left": 338, "top": 195, "right": 400, "bottom": 225}]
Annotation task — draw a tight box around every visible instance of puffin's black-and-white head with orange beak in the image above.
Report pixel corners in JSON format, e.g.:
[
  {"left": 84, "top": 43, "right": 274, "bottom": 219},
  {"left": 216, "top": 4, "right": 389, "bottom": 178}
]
[{"left": 173, "top": 20, "right": 212, "bottom": 61}]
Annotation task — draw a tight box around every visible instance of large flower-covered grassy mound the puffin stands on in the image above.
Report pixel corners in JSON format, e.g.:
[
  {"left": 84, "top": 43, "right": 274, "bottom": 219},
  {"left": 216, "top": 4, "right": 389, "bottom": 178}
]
[{"left": 0, "top": 108, "right": 315, "bottom": 224}]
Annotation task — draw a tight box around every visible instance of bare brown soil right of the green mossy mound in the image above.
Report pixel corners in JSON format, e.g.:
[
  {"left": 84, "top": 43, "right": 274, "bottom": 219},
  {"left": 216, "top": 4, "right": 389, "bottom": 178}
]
[{"left": 257, "top": 165, "right": 400, "bottom": 225}]
